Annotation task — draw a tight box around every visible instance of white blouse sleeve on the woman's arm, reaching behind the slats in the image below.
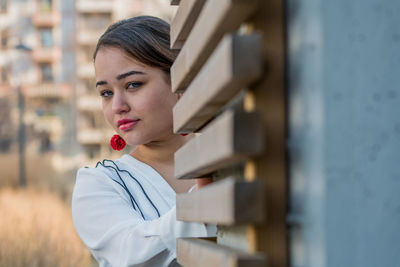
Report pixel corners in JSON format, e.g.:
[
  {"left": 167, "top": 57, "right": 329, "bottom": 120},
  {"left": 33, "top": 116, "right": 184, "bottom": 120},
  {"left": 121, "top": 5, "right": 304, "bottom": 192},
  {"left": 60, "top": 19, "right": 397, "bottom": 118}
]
[{"left": 72, "top": 168, "right": 214, "bottom": 266}]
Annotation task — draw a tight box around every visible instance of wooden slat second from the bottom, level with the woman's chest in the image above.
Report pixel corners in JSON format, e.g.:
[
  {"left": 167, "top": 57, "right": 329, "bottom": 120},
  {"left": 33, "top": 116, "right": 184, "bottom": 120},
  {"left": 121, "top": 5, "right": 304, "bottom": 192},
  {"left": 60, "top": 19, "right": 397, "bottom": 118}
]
[{"left": 176, "top": 178, "right": 265, "bottom": 225}]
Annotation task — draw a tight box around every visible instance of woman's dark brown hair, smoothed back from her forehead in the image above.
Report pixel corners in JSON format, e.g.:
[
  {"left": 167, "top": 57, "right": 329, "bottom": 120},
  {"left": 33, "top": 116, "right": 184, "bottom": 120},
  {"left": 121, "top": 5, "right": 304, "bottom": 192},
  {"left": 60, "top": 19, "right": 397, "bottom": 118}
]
[{"left": 93, "top": 16, "right": 177, "bottom": 74}]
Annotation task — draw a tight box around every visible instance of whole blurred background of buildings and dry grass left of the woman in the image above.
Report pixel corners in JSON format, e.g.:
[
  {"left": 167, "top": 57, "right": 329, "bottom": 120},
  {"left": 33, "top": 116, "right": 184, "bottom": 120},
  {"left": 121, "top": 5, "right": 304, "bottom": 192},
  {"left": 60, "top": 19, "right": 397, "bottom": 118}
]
[{"left": 0, "top": 0, "right": 176, "bottom": 267}]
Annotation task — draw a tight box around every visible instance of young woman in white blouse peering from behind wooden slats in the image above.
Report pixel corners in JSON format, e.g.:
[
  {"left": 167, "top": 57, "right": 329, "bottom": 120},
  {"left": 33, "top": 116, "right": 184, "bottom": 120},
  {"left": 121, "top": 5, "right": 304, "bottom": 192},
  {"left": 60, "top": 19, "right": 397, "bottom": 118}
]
[{"left": 72, "top": 16, "right": 216, "bottom": 267}]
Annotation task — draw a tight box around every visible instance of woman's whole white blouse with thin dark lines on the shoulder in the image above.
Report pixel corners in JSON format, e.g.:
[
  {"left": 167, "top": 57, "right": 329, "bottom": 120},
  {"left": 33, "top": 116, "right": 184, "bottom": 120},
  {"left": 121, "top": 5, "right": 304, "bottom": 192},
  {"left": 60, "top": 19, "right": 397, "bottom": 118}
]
[{"left": 72, "top": 155, "right": 216, "bottom": 267}]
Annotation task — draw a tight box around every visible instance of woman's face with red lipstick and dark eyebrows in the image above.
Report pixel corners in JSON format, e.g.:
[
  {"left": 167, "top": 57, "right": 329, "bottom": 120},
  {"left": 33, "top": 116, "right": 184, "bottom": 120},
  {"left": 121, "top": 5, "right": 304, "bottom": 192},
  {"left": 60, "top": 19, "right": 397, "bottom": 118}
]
[{"left": 94, "top": 47, "right": 178, "bottom": 145}]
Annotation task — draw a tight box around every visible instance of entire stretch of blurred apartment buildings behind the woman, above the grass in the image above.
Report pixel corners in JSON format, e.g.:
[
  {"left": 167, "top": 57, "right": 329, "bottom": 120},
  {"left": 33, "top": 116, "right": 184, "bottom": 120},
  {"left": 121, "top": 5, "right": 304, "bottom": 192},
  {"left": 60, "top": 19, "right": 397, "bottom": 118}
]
[{"left": 0, "top": 0, "right": 175, "bottom": 171}]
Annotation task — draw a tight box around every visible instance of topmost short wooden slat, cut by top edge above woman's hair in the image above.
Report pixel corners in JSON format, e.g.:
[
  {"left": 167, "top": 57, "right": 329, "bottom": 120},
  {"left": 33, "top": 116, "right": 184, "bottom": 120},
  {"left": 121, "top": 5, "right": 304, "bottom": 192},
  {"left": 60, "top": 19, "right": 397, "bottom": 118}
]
[{"left": 171, "top": 0, "right": 206, "bottom": 49}]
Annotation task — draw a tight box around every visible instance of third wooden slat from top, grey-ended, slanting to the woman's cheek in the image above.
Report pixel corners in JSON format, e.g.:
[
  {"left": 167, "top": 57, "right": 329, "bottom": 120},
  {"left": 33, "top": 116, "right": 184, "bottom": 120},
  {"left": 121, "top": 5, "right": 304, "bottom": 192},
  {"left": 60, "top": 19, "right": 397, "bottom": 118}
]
[{"left": 173, "top": 34, "right": 262, "bottom": 133}]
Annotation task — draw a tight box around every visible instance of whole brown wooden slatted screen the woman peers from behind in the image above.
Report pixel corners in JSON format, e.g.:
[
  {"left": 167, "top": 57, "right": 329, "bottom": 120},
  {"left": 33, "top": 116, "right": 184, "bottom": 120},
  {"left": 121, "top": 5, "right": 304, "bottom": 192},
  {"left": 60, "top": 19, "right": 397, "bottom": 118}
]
[{"left": 171, "top": 0, "right": 288, "bottom": 267}]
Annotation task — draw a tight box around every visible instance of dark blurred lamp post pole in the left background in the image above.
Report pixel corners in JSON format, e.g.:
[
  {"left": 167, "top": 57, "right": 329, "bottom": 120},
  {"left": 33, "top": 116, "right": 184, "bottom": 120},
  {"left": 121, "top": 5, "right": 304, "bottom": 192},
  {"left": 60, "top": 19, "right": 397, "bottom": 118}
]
[{"left": 18, "top": 86, "right": 26, "bottom": 187}]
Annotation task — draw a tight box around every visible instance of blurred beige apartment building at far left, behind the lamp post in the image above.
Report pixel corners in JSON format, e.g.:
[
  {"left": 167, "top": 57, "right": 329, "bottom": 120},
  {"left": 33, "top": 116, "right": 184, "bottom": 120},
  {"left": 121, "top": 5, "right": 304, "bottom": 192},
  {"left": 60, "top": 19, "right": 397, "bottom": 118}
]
[{"left": 0, "top": 0, "right": 73, "bottom": 159}]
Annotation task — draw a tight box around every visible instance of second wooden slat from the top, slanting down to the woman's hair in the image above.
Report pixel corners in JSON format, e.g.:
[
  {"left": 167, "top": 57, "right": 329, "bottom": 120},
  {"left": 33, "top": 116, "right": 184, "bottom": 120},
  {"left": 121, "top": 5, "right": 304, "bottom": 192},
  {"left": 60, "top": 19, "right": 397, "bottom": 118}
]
[{"left": 171, "top": 0, "right": 257, "bottom": 92}]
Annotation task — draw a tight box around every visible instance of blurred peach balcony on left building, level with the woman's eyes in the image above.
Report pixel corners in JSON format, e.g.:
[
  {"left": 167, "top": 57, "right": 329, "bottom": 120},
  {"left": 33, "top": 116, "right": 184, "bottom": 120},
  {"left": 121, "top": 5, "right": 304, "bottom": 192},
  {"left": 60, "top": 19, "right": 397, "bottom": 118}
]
[{"left": 22, "top": 83, "right": 72, "bottom": 98}]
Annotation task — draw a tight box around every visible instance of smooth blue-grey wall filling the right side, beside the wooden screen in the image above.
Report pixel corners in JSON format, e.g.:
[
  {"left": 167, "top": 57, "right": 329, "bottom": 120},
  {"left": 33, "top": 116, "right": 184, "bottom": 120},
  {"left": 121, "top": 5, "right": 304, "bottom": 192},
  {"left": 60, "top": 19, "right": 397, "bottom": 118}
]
[{"left": 287, "top": 0, "right": 400, "bottom": 267}]
